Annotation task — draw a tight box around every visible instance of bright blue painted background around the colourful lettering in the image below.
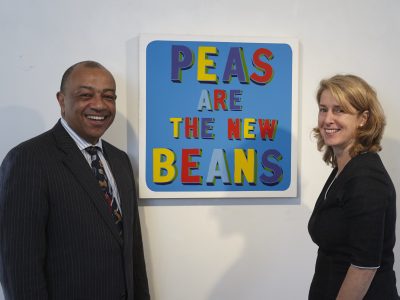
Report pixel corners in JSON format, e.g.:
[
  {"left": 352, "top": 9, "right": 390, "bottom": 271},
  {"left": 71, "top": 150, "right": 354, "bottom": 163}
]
[{"left": 145, "top": 41, "right": 293, "bottom": 192}]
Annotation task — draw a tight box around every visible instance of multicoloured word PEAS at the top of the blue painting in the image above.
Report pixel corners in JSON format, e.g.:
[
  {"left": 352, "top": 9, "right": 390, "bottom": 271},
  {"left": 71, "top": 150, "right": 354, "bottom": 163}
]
[{"left": 171, "top": 45, "right": 274, "bottom": 85}]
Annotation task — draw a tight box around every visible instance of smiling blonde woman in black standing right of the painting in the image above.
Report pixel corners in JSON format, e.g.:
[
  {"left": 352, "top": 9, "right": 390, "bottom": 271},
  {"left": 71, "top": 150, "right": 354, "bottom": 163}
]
[{"left": 308, "top": 75, "right": 400, "bottom": 300}]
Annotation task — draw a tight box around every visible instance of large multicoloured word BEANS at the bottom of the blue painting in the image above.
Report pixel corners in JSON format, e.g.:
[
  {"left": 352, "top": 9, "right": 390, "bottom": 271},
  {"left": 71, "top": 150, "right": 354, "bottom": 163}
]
[{"left": 153, "top": 148, "right": 283, "bottom": 186}]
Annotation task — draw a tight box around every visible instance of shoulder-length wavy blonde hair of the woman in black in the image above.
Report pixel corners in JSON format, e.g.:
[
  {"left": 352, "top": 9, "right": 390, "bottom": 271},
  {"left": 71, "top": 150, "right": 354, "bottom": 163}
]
[{"left": 313, "top": 75, "right": 386, "bottom": 167}]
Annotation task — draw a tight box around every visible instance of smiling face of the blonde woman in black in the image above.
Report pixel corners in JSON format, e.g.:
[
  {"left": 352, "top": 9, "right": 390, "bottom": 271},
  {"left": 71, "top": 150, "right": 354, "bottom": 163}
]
[{"left": 318, "top": 90, "right": 366, "bottom": 154}]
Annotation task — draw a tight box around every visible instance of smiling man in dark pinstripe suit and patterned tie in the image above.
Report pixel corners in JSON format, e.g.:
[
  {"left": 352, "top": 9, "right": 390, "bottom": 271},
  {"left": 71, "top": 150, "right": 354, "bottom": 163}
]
[{"left": 0, "top": 61, "right": 150, "bottom": 300}]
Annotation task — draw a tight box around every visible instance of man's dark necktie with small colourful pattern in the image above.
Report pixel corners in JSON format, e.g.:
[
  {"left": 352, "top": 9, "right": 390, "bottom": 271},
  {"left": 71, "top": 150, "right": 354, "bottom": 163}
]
[{"left": 85, "top": 146, "right": 122, "bottom": 236}]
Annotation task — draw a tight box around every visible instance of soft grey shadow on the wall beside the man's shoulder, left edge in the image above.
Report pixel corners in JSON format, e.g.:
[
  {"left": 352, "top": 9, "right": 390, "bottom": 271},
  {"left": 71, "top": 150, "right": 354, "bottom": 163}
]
[{"left": 0, "top": 106, "right": 47, "bottom": 161}]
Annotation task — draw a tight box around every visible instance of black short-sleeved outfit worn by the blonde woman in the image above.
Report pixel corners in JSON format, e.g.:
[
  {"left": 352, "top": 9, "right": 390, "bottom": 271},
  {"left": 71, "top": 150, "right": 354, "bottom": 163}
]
[{"left": 308, "top": 152, "right": 400, "bottom": 300}]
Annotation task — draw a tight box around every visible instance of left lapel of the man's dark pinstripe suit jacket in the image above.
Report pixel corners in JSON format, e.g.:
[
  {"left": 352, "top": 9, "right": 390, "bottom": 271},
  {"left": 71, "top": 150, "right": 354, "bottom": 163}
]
[{"left": 53, "top": 122, "right": 122, "bottom": 244}]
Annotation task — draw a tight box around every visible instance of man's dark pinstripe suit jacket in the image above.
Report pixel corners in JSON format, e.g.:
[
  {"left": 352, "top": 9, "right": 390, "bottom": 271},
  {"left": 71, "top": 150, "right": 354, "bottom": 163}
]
[{"left": 0, "top": 122, "right": 150, "bottom": 300}]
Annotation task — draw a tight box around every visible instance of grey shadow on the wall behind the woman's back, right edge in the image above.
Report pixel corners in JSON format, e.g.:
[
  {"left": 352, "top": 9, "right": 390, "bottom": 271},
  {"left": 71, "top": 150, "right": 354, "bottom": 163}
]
[{"left": 380, "top": 138, "right": 400, "bottom": 284}]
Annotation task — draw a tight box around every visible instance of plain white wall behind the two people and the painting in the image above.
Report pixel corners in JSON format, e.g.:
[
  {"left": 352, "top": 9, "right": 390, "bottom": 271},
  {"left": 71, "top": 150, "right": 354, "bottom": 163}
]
[{"left": 0, "top": 0, "right": 400, "bottom": 300}]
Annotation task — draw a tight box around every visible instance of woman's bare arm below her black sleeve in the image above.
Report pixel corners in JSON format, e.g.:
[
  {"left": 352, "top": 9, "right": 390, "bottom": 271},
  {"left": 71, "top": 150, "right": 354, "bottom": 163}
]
[{"left": 336, "top": 266, "right": 377, "bottom": 300}]
